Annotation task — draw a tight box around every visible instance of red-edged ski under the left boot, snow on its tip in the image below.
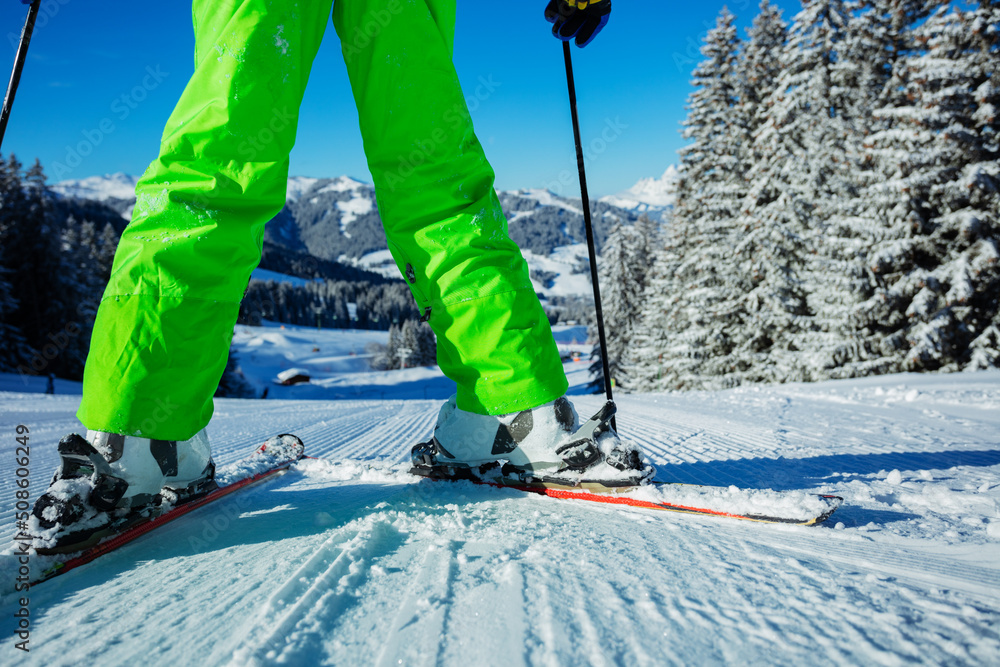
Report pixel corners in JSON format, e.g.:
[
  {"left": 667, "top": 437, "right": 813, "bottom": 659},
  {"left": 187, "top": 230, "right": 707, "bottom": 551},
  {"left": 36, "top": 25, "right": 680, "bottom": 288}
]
[{"left": 14, "top": 433, "right": 305, "bottom": 585}]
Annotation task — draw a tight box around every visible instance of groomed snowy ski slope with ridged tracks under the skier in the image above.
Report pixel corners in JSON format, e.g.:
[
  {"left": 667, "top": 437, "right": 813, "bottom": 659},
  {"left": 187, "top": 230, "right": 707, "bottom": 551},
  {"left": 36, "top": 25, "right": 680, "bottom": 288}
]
[{"left": 0, "top": 327, "right": 1000, "bottom": 665}]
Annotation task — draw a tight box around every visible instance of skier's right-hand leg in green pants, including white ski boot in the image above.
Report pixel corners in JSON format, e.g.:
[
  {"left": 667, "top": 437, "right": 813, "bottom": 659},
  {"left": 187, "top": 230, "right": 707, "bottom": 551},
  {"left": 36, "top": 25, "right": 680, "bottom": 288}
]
[{"left": 333, "top": 0, "right": 652, "bottom": 487}]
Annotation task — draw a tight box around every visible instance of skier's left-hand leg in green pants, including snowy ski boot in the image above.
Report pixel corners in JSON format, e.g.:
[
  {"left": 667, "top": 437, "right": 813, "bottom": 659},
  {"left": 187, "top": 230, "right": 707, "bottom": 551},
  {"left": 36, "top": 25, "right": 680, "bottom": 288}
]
[{"left": 34, "top": 0, "right": 331, "bottom": 545}]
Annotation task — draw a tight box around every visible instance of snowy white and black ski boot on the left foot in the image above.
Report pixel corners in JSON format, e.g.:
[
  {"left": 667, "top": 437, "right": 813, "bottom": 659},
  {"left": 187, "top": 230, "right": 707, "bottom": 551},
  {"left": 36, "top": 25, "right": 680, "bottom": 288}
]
[{"left": 27, "top": 431, "right": 217, "bottom": 553}]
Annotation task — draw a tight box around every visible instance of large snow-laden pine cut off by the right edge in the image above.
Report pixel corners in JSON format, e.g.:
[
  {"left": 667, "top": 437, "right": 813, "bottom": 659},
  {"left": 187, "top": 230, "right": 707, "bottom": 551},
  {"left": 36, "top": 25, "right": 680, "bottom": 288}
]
[{"left": 857, "top": 2, "right": 1000, "bottom": 370}]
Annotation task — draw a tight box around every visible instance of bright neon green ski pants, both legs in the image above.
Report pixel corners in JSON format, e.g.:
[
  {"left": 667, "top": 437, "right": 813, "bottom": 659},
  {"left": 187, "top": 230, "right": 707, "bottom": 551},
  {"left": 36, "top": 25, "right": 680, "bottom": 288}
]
[{"left": 79, "top": 0, "right": 567, "bottom": 440}]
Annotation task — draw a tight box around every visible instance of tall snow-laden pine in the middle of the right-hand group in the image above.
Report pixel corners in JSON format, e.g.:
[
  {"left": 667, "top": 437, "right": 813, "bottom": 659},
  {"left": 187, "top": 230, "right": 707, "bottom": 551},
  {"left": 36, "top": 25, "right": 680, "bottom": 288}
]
[{"left": 743, "top": 0, "right": 854, "bottom": 381}]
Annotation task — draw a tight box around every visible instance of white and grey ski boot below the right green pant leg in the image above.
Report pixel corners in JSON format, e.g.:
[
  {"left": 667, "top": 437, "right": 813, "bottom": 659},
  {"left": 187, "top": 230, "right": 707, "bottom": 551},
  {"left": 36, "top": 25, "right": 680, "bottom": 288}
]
[{"left": 411, "top": 397, "right": 655, "bottom": 491}]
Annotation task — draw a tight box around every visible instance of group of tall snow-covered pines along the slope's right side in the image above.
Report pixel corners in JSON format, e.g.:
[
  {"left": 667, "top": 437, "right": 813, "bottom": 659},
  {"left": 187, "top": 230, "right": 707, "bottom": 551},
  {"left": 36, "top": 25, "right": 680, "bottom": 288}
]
[{"left": 603, "top": 0, "right": 1000, "bottom": 390}]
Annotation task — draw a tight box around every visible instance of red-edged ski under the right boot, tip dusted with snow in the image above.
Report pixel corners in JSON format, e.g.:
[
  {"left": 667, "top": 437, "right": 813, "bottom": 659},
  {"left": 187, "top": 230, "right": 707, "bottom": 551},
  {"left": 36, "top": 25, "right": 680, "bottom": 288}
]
[{"left": 410, "top": 466, "right": 844, "bottom": 526}]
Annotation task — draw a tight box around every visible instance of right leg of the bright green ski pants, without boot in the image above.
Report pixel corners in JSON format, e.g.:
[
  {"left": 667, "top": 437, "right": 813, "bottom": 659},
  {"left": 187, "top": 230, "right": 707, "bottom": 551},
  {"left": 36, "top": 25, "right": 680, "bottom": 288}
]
[{"left": 333, "top": 0, "right": 567, "bottom": 414}]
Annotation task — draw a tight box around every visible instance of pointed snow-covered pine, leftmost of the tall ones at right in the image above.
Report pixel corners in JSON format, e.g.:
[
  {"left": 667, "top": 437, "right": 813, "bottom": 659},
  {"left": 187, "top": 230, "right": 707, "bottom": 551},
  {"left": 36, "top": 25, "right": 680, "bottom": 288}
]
[{"left": 633, "top": 8, "right": 746, "bottom": 389}]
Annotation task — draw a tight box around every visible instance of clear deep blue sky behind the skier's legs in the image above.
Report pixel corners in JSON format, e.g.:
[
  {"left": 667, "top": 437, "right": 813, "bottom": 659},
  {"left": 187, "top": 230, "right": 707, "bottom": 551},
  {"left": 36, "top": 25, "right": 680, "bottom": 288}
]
[{"left": 0, "top": 0, "right": 800, "bottom": 196}]
